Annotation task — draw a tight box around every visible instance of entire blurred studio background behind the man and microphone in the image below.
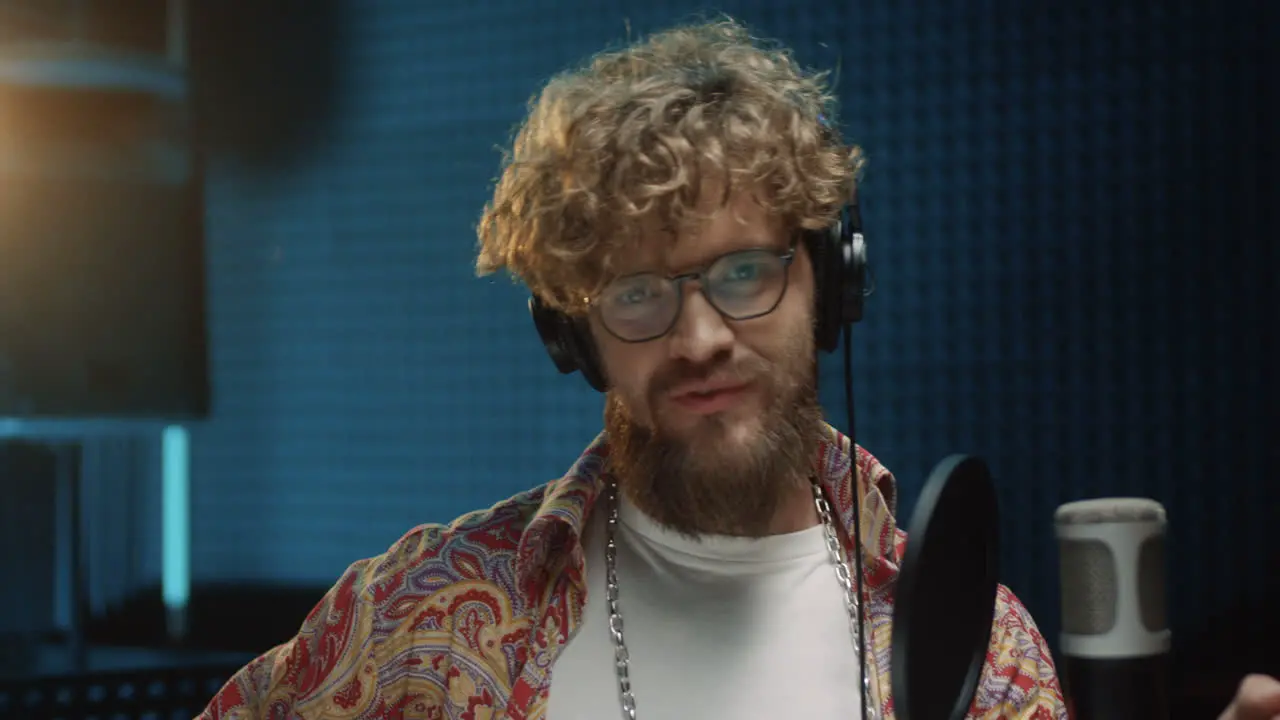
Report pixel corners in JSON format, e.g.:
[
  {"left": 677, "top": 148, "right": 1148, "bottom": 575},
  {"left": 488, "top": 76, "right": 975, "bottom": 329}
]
[{"left": 0, "top": 0, "right": 1280, "bottom": 717}]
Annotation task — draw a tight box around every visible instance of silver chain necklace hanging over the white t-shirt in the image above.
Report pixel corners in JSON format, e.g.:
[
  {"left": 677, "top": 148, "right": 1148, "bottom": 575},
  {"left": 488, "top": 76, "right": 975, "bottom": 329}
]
[{"left": 604, "top": 480, "right": 878, "bottom": 720}]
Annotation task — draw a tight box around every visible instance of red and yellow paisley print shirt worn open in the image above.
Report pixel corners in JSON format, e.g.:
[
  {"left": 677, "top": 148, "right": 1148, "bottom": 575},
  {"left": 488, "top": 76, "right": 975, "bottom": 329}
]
[{"left": 200, "top": 427, "right": 1066, "bottom": 720}]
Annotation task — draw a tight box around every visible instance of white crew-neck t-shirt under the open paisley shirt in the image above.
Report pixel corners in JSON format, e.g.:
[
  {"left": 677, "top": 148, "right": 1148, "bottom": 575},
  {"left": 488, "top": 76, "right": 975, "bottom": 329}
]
[{"left": 548, "top": 496, "right": 861, "bottom": 720}]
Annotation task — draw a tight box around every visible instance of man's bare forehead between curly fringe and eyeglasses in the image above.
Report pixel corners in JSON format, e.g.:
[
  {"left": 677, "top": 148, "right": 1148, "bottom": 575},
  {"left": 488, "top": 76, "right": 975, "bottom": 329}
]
[{"left": 611, "top": 191, "right": 786, "bottom": 274}]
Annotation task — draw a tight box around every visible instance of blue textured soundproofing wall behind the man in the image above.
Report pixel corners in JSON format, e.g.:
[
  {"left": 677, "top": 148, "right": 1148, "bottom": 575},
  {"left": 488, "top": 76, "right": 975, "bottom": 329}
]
[{"left": 177, "top": 0, "right": 1280, "bottom": 676}]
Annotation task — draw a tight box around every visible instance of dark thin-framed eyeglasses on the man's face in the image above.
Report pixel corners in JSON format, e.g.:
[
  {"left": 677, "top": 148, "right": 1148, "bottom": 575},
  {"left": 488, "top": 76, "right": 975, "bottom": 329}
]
[{"left": 591, "top": 246, "right": 796, "bottom": 342}]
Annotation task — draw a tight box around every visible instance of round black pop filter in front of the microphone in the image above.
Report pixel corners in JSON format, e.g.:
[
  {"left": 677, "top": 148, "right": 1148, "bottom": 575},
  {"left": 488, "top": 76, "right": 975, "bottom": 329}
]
[{"left": 891, "top": 455, "right": 1000, "bottom": 720}]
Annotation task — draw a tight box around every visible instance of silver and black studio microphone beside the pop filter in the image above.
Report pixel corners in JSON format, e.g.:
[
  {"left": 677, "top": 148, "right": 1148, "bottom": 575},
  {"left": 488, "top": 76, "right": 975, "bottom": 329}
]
[{"left": 1053, "top": 497, "right": 1171, "bottom": 720}]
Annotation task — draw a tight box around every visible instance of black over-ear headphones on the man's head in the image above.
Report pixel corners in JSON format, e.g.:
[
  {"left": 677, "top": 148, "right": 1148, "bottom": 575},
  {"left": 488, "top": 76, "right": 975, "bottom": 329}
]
[{"left": 529, "top": 192, "right": 874, "bottom": 392}]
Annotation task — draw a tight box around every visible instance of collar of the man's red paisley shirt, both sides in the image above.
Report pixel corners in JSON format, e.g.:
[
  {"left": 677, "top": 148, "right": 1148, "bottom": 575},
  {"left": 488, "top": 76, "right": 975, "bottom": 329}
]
[{"left": 516, "top": 424, "right": 901, "bottom": 589}]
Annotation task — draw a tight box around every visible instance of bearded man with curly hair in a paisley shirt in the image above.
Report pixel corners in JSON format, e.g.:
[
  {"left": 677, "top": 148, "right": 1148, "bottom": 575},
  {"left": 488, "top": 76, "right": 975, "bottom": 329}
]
[{"left": 194, "top": 22, "right": 1066, "bottom": 720}]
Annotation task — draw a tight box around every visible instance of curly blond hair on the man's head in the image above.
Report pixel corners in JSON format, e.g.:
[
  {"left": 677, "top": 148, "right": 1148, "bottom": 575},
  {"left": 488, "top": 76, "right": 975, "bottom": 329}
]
[{"left": 476, "top": 19, "right": 863, "bottom": 313}]
